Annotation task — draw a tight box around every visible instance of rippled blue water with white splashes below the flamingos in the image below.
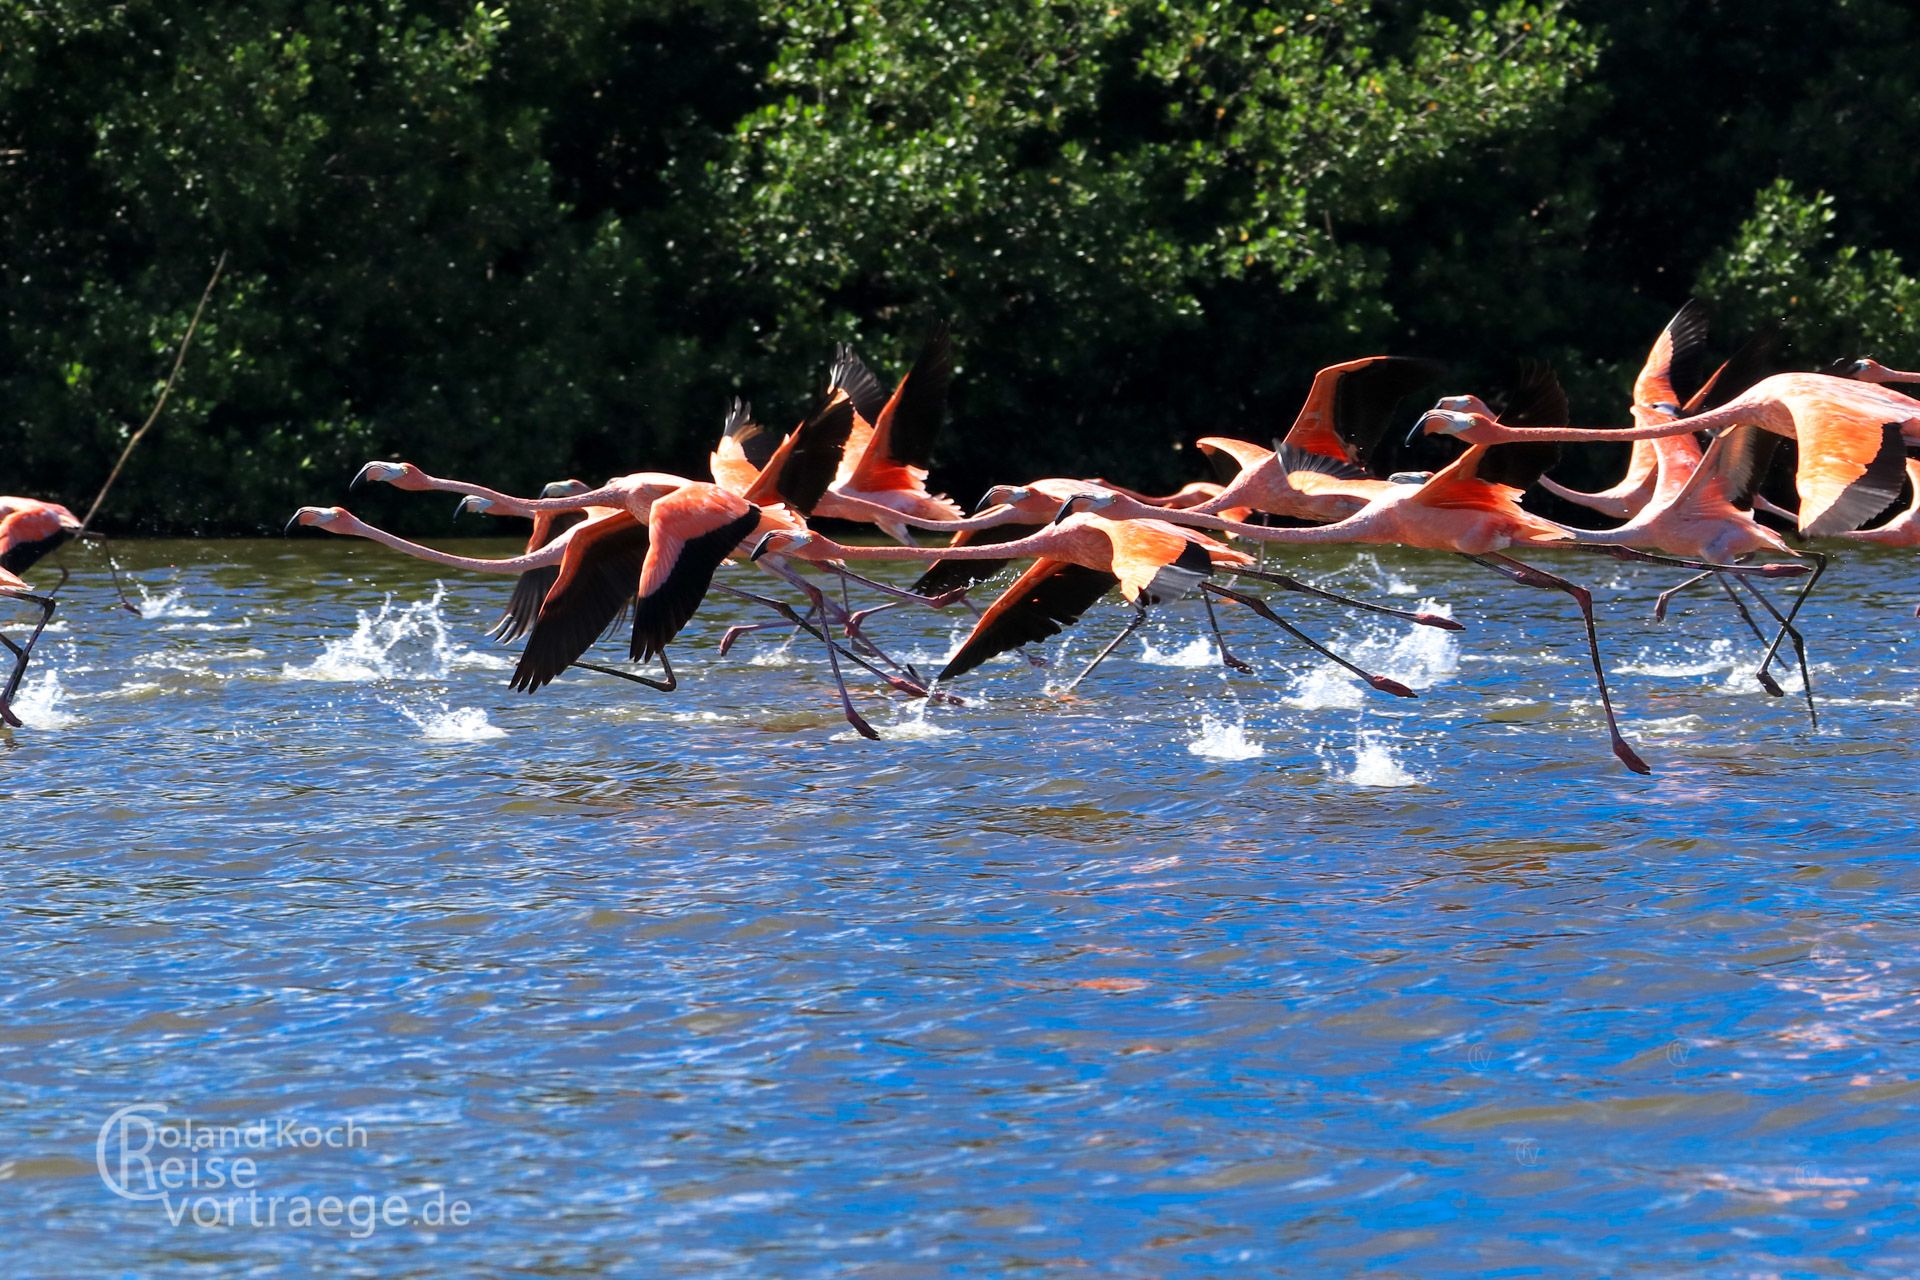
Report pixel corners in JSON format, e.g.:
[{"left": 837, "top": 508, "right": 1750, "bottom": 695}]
[{"left": 0, "top": 537, "right": 1920, "bottom": 1276}]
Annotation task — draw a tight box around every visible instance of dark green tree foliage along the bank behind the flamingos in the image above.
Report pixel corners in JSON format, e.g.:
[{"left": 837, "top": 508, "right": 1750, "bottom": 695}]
[{"left": 0, "top": 0, "right": 1920, "bottom": 530}]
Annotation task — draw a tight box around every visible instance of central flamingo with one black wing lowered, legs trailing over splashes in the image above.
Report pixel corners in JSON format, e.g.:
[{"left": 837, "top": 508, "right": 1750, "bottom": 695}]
[{"left": 753, "top": 510, "right": 1459, "bottom": 699}]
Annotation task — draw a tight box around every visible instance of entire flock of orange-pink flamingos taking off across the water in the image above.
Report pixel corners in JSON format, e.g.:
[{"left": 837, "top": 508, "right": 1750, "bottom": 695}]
[{"left": 0, "top": 303, "right": 1920, "bottom": 773}]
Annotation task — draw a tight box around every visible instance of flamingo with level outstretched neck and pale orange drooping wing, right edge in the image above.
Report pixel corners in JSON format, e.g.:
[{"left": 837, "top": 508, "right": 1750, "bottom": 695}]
[{"left": 1415, "top": 372, "right": 1920, "bottom": 537}]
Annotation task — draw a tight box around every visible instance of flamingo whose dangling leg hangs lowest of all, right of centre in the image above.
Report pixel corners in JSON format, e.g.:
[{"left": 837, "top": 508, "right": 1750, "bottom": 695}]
[{"left": 1062, "top": 445, "right": 1807, "bottom": 773}]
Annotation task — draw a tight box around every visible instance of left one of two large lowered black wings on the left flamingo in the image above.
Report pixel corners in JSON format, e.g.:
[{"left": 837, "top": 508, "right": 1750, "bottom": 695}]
[{"left": 507, "top": 510, "right": 649, "bottom": 693}]
